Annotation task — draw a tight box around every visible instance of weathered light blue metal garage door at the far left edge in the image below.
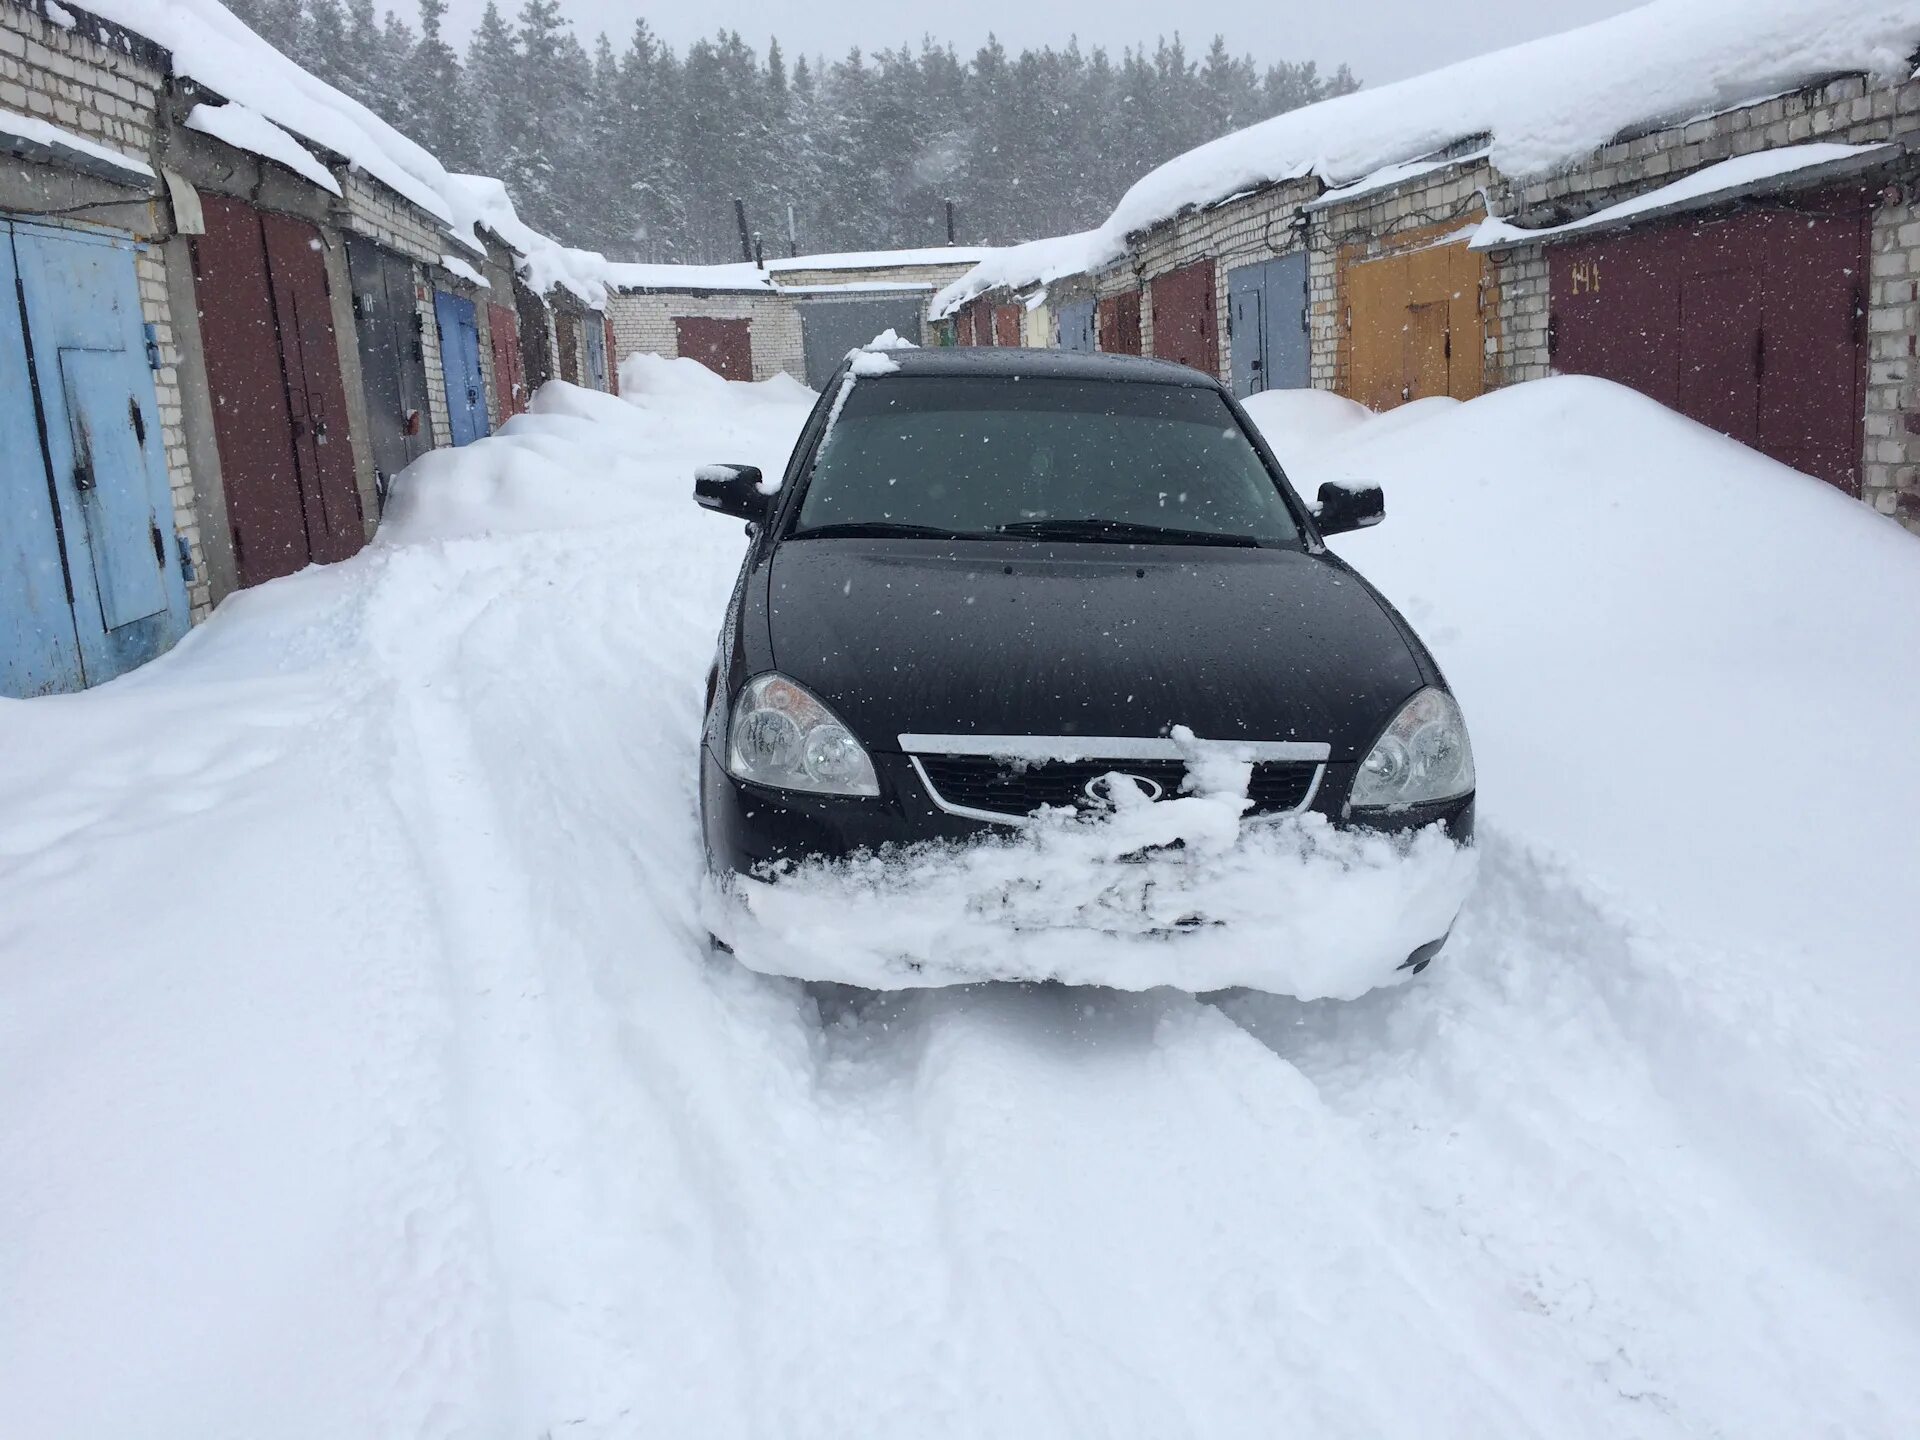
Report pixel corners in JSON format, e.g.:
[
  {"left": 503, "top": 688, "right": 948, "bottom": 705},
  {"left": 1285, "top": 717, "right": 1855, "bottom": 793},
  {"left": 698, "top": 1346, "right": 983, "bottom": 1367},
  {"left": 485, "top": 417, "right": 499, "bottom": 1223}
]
[{"left": 0, "top": 219, "right": 188, "bottom": 697}]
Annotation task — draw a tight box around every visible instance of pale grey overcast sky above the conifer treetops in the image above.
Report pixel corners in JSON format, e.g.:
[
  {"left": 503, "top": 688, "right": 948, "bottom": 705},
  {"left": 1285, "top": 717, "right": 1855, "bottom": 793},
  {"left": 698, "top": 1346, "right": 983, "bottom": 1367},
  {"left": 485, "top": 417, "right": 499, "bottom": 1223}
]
[{"left": 445, "top": 0, "right": 1636, "bottom": 84}]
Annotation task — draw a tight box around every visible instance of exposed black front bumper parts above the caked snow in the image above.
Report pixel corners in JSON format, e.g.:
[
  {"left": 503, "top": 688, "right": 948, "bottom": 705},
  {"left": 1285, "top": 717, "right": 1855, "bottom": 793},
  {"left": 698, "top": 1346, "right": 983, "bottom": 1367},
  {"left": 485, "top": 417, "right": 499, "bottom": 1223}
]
[{"left": 701, "top": 745, "right": 1475, "bottom": 874}]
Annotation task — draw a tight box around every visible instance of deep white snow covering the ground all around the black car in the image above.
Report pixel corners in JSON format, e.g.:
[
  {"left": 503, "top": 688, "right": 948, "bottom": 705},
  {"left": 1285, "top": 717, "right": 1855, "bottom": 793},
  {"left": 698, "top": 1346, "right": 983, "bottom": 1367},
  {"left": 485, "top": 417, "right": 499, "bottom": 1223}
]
[{"left": 0, "top": 361, "right": 1920, "bottom": 1440}]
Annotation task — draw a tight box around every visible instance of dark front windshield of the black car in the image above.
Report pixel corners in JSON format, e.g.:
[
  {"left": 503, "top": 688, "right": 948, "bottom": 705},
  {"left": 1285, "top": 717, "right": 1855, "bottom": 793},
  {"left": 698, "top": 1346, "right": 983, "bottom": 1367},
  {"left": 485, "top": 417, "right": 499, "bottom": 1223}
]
[{"left": 793, "top": 376, "right": 1300, "bottom": 545}]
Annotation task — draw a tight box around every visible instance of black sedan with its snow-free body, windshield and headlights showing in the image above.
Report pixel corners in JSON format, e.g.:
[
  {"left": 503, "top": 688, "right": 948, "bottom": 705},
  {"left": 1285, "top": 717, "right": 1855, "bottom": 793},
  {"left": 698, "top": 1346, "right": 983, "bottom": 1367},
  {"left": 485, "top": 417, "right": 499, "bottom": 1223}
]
[{"left": 695, "top": 349, "right": 1475, "bottom": 966}]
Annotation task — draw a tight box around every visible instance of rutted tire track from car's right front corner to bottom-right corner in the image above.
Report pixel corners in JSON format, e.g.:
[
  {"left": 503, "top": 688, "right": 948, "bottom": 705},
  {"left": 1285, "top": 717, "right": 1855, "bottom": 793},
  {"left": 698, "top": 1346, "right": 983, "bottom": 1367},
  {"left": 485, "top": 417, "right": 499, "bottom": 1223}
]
[{"left": 1219, "top": 826, "right": 1920, "bottom": 1440}]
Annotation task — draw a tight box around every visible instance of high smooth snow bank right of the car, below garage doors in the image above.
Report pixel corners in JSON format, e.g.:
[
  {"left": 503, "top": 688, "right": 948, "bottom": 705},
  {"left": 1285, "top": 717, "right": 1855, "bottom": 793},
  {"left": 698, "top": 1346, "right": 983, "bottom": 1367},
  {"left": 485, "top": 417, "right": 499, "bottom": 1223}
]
[{"left": 1256, "top": 376, "right": 1920, "bottom": 1006}]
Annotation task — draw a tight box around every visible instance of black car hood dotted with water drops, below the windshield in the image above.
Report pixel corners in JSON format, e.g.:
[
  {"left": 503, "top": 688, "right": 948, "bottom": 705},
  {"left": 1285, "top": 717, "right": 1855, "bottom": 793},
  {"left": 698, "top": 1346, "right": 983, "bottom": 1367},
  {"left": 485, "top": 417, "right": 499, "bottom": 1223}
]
[{"left": 766, "top": 538, "right": 1425, "bottom": 760}]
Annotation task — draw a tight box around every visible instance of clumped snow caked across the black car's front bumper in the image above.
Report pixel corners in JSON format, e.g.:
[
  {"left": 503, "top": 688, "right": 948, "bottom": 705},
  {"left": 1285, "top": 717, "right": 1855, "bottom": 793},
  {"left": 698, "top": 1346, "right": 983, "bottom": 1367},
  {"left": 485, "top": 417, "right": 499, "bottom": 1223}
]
[{"left": 705, "top": 795, "right": 1475, "bottom": 1000}]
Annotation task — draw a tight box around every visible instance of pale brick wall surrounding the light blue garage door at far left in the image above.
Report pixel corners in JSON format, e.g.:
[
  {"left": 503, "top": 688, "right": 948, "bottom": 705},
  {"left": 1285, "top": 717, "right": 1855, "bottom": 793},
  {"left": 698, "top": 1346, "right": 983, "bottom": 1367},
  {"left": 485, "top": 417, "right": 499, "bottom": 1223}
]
[{"left": 0, "top": 0, "right": 211, "bottom": 622}]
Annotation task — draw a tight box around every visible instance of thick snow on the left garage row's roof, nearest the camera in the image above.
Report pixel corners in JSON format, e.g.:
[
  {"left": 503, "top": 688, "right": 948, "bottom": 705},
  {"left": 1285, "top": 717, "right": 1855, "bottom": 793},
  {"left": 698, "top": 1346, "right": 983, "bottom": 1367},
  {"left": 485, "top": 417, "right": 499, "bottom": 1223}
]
[{"left": 86, "top": 0, "right": 467, "bottom": 242}]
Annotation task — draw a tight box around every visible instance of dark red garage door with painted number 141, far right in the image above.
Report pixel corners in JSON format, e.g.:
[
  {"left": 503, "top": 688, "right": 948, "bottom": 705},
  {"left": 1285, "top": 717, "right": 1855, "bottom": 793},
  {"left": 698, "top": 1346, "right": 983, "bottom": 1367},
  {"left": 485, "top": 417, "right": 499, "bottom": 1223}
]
[{"left": 1548, "top": 190, "right": 1868, "bottom": 495}]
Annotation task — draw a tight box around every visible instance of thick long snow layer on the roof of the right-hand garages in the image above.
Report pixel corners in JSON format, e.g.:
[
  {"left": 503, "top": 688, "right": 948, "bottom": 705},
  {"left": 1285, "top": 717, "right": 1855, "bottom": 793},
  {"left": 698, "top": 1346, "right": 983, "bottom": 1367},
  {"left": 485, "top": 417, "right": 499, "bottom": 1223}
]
[{"left": 1102, "top": 0, "right": 1920, "bottom": 234}]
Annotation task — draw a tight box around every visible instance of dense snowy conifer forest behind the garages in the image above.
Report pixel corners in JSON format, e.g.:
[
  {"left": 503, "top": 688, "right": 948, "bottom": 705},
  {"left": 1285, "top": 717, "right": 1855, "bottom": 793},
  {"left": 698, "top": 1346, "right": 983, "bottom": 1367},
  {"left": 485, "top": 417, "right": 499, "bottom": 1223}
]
[{"left": 230, "top": 0, "right": 1359, "bottom": 263}]
